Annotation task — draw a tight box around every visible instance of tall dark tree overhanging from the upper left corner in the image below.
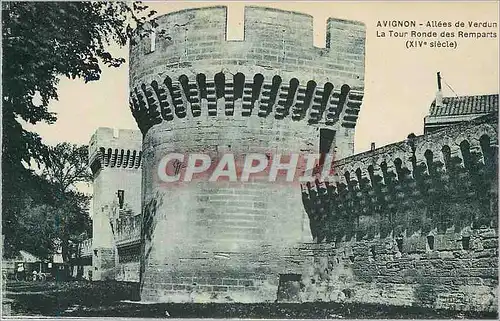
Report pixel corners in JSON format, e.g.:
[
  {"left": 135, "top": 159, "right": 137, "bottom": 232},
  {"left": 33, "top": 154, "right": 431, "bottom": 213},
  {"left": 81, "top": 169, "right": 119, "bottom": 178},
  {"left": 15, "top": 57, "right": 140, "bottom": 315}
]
[{"left": 2, "top": 2, "right": 156, "bottom": 253}]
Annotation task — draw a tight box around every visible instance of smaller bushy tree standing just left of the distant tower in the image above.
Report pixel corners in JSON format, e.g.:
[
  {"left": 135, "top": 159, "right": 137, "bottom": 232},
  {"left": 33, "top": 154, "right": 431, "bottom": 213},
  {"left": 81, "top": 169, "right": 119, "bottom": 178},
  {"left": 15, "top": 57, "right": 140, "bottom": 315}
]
[{"left": 6, "top": 143, "right": 91, "bottom": 262}]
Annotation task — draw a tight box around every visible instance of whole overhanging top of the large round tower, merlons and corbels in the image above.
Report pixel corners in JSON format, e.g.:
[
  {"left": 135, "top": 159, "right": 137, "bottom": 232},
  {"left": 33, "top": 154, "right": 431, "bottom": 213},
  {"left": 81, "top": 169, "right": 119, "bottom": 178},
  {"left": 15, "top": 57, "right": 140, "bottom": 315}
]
[{"left": 130, "top": 6, "right": 365, "bottom": 133}]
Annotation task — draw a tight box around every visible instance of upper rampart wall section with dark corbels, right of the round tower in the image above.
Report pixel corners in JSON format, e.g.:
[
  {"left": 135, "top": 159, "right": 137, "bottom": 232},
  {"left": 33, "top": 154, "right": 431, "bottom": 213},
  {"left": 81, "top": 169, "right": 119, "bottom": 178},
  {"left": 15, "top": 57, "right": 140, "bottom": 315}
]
[{"left": 302, "top": 115, "right": 498, "bottom": 242}]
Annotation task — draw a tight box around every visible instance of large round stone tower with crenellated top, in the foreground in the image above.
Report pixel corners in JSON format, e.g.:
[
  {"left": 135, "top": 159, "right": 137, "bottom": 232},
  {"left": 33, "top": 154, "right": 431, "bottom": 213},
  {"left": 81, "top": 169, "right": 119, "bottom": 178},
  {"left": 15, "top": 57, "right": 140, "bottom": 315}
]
[{"left": 130, "top": 7, "right": 365, "bottom": 302}]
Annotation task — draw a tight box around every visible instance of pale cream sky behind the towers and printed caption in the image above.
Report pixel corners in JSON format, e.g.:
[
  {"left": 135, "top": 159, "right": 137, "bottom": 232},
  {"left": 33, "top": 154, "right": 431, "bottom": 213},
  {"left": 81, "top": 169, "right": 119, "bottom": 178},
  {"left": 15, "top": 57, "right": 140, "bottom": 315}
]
[{"left": 26, "top": 1, "right": 499, "bottom": 152}]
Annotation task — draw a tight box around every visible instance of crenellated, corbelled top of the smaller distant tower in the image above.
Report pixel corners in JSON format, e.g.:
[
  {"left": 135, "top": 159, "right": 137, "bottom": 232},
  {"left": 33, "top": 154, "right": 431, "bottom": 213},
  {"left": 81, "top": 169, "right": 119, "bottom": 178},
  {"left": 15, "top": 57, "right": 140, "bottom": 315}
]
[{"left": 89, "top": 127, "right": 142, "bottom": 174}]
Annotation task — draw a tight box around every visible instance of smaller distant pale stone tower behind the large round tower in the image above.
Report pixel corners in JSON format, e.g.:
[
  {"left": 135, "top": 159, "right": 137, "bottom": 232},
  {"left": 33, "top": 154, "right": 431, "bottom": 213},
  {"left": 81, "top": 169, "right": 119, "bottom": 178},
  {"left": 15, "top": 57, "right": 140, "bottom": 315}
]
[{"left": 84, "top": 128, "right": 142, "bottom": 281}]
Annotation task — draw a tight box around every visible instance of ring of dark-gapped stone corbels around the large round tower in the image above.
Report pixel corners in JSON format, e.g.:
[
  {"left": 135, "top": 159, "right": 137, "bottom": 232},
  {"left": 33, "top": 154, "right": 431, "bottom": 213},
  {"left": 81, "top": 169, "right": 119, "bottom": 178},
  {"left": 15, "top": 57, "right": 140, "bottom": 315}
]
[{"left": 130, "top": 72, "right": 363, "bottom": 134}]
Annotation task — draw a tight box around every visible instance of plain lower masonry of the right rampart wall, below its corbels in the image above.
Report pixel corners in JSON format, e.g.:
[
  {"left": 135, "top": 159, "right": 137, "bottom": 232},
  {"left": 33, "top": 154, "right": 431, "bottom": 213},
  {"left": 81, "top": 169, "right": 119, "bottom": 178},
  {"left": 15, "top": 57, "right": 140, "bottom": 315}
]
[{"left": 296, "top": 228, "right": 498, "bottom": 311}]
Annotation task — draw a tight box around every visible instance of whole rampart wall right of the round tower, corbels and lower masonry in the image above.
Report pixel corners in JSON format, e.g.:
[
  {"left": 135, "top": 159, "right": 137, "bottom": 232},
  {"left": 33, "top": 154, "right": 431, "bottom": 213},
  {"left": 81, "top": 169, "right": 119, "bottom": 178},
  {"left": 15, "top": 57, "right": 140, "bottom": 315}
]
[{"left": 294, "top": 115, "right": 498, "bottom": 311}]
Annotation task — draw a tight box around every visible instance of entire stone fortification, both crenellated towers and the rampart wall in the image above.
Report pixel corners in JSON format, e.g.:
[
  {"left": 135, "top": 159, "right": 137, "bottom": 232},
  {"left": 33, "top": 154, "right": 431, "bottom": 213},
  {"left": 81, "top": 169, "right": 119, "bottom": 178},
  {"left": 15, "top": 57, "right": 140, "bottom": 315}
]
[{"left": 85, "top": 7, "right": 498, "bottom": 310}]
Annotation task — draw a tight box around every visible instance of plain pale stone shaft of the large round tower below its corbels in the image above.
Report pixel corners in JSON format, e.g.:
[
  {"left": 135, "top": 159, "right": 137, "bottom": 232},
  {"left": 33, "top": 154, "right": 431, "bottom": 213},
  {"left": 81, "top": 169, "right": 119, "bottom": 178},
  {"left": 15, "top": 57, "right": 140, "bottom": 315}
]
[{"left": 143, "top": 118, "right": 320, "bottom": 302}]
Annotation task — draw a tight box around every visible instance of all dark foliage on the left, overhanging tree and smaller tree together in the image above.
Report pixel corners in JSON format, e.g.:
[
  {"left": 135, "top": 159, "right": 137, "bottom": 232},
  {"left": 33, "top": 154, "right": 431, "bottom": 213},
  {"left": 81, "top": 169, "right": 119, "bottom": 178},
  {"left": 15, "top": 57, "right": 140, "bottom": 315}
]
[{"left": 2, "top": 1, "right": 155, "bottom": 254}]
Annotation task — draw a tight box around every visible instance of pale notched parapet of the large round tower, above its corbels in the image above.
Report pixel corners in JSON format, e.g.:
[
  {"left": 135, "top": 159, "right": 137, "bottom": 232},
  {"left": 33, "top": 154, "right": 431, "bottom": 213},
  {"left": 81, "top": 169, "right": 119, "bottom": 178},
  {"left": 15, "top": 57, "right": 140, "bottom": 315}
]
[{"left": 130, "top": 6, "right": 365, "bottom": 90}]
